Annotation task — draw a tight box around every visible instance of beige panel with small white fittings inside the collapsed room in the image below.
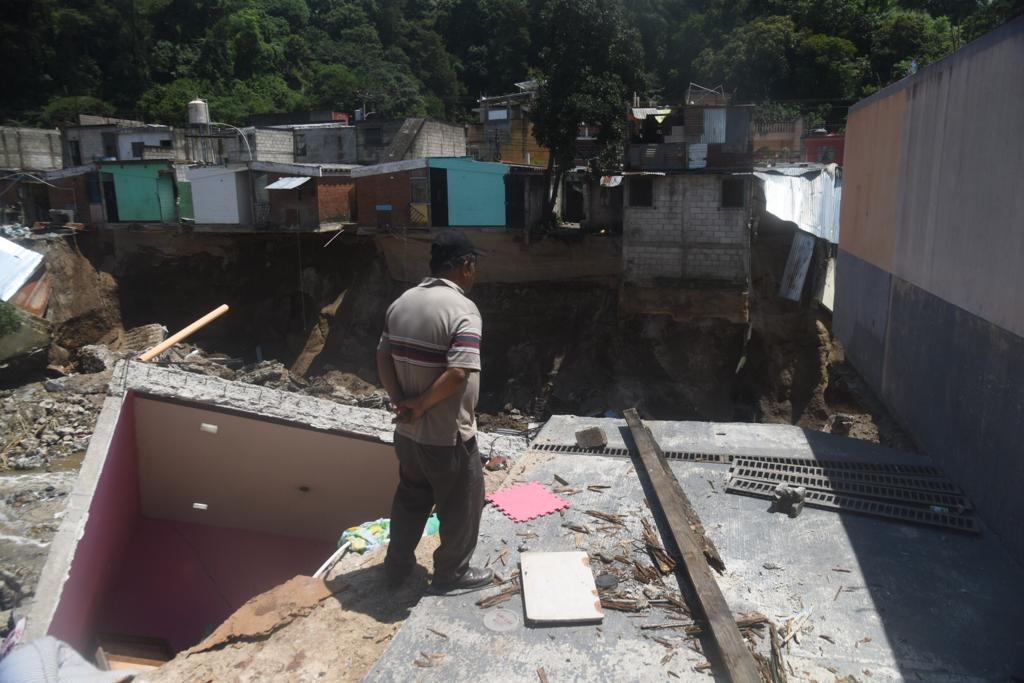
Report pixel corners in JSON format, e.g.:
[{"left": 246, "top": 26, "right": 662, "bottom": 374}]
[{"left": 134, "top": 397, "right": 398, "bottom": 542}]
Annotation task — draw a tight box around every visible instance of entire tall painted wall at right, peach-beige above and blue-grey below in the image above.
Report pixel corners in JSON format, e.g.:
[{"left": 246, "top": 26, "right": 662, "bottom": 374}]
[{"left": 835, "top": 18, "right": 1024, "bottom": 561}]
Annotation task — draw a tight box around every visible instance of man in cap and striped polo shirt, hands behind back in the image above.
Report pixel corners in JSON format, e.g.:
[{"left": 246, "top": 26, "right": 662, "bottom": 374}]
[{"left": 377, "top": 230, "right": 494, "bottom": 592}]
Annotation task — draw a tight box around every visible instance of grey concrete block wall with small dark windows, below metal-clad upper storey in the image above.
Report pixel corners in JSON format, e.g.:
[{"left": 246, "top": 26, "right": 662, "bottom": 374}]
[{"left": 623, "top": 174, "right": 750, "bottom": 284}]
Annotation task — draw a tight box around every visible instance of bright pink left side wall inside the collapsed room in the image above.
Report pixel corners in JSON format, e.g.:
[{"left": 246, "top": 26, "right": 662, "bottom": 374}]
[{"left": 48, "top": 393, "right": 139, "bottom": 653}]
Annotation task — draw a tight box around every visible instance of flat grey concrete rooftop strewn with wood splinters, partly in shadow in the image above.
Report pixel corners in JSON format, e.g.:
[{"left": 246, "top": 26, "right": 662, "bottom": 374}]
[{"left": 368, "top": 417, "right": 1024, "bottom": 681}]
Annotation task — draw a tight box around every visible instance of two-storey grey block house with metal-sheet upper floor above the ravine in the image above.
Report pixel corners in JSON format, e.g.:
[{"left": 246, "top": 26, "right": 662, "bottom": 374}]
[{"left": 623, "top": 95, "right": 753, "bottom": 322}]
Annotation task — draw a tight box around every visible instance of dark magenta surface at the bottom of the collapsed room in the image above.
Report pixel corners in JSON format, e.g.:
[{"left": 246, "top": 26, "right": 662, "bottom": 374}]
[{"left": 97, "top": 518, "right": 335, "bottom": 652}]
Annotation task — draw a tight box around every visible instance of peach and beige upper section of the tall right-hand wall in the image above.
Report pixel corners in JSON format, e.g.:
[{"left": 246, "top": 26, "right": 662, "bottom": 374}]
[{"left": 840, "top": 19, "right": 1024, "bottom": 336}]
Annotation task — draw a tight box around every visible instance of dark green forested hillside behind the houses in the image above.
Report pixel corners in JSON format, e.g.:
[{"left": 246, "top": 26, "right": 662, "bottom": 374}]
[{"left": 0, "top": 0, "right": 1024, "bottom": 125}]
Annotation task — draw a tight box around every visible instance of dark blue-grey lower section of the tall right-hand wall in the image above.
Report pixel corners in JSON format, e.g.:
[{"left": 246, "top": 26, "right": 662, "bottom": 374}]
[{"left": 835, "top": 251, "right": 1024, "bottom": 561}]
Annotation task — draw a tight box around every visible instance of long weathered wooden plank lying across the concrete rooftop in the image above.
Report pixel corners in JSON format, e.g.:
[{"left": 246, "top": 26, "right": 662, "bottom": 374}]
[{"left": 624, "top": 409, "right": 762, "bottom": 683}]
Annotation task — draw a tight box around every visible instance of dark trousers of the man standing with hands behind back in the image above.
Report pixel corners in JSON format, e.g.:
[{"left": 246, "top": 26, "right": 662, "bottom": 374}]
[{"left": 384, "top": 434, "right": 483, "bottom": 585}]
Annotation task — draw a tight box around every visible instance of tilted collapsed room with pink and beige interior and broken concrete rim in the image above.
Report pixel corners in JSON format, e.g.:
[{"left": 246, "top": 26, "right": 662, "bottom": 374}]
[{"left": 27, "top": 361, "right": 524, "bottom": 655}]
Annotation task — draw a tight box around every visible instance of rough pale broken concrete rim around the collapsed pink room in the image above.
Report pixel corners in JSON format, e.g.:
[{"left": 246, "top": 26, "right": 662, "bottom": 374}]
[{"left": 19, "top": 360, "right": 526, "bottom": 642}]
